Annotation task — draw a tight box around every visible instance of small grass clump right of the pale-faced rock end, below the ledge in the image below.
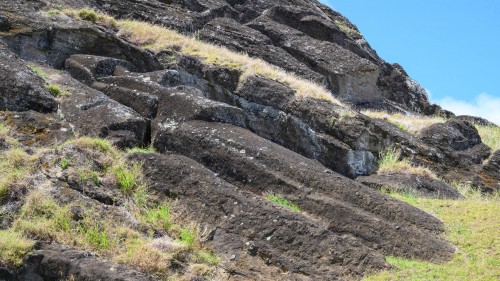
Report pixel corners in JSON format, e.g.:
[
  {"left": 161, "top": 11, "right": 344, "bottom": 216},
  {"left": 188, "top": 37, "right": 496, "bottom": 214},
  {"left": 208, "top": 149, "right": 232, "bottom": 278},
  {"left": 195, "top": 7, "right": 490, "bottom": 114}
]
[{"left": 377, "top": 148, "right": 437, "bottom": 179}]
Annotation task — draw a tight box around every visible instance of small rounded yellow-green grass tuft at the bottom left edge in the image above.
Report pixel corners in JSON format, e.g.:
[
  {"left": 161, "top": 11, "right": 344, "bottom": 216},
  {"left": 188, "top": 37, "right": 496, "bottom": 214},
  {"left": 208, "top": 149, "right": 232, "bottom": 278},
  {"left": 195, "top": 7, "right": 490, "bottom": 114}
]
[{"left": 0, "top": 230, "right": 35, "bottom": 266}]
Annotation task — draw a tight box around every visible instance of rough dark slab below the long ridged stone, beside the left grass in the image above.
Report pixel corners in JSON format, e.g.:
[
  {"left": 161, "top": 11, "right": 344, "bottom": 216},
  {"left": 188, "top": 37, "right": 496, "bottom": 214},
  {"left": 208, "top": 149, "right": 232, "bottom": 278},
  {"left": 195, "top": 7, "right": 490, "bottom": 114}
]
[{"left": 131, "top": 154, "right": 386, "bottom": 280}]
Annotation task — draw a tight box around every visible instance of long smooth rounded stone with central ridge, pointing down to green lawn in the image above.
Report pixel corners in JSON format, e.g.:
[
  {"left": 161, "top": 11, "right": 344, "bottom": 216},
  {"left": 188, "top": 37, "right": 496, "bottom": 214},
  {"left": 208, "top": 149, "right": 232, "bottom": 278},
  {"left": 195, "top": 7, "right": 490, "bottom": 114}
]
[{"left": 154, "top": 121, "right": 453, "bottom": 259}]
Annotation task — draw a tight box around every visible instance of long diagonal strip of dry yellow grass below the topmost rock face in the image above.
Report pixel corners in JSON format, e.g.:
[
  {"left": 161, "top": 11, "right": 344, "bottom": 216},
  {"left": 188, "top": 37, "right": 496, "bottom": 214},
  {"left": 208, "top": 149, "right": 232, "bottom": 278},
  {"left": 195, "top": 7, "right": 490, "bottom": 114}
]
[{"left": 118, "top": 20, "right": 340, "bottom": 104}]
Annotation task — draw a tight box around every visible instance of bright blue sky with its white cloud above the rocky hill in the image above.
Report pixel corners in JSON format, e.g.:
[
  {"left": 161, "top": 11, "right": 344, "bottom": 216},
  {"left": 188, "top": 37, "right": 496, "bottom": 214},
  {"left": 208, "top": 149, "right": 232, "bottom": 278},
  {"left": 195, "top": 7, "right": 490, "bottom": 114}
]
[{"left": 320, "top": 0, "right": 500, "bottom": 124}]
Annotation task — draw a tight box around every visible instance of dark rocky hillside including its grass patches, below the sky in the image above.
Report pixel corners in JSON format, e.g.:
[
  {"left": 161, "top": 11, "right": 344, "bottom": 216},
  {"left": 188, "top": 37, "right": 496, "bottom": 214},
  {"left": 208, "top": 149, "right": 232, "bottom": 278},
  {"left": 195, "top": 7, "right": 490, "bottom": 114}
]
[{"left": 0, "top": 0, "right": 500, "bottom": 280}]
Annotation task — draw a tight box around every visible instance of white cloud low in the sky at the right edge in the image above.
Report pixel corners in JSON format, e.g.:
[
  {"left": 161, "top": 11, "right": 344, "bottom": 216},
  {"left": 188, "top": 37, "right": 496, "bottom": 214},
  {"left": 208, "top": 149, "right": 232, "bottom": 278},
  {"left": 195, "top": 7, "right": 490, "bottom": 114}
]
[{"left": 433, "top": 93, "right": 500, "bottom": 125}]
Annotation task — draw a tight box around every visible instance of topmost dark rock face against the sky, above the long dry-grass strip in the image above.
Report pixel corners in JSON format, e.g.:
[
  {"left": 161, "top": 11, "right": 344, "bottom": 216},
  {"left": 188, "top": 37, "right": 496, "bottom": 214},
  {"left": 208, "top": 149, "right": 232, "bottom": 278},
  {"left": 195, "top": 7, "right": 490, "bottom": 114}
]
[{"left": 92, "top": 0, "right": 436, "bottom": 113}]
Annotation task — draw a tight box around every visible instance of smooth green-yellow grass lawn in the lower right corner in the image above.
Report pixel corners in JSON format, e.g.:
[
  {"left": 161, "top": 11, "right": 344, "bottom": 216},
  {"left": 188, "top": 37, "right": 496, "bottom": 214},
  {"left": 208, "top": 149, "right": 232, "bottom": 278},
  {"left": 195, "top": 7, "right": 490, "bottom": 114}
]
[{"left": 364, "top": 185, "right": 500, "bottom": 281}]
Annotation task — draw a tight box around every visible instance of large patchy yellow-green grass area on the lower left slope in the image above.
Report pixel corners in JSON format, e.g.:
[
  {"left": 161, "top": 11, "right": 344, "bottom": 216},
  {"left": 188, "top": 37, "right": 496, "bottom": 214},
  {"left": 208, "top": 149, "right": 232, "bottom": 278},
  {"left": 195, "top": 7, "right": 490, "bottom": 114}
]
[{"left": 0, "top": 132, "right": 219, "bottom": 280}]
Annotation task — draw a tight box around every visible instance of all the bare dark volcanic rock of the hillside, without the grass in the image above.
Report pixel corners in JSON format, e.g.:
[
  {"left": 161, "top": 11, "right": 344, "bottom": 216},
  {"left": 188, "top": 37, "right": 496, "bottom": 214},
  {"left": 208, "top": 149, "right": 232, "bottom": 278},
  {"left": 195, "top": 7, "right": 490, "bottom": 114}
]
[{"left": 0, "top": 0, "right": 499, "bottom": 280}]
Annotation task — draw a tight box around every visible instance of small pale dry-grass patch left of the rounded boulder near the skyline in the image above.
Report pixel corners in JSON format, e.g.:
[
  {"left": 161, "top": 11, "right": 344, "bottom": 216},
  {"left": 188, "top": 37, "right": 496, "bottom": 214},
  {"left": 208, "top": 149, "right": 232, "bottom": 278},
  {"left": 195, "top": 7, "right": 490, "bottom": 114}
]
[{"left": 361, "top": 110, "right": 446, "bottom": 134}]
